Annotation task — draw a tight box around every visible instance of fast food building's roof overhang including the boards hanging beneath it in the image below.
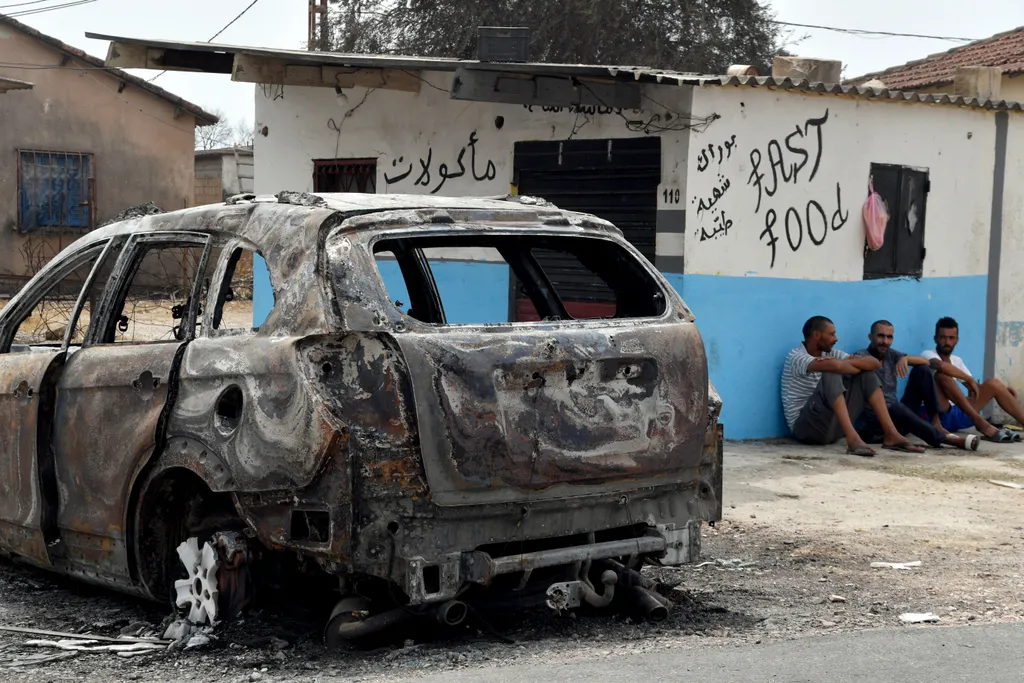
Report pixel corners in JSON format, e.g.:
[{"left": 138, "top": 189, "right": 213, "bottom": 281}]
[{"left": 86, "top": 33, "right": 1024, "bottom": 112}]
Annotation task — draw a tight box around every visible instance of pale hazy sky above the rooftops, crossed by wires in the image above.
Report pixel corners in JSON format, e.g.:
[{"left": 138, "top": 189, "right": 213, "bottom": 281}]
[{"left": 6, "top": 0, "right": 1024, "bottom": 124}]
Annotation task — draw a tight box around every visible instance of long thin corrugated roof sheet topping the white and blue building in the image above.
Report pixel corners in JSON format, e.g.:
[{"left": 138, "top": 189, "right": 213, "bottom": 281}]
[{"left": 86, "top": 33, "right": 1024, "bottom": 112}]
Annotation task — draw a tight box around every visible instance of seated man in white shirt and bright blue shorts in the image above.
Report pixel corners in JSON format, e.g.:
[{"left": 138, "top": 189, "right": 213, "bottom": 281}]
[{"left": 903, "top": 317, "right": 1024, "bottom": 443}]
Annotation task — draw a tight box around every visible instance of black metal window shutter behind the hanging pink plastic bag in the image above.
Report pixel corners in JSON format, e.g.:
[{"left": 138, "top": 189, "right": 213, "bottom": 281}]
[{"left": 864, "top": 164, "right": 929, "bottom": 280}]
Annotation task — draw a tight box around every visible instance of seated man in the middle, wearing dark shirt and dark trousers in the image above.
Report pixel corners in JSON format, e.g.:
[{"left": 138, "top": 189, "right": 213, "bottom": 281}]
[{"left": 855, "top": 321, "right": 979, "bottom": 451}]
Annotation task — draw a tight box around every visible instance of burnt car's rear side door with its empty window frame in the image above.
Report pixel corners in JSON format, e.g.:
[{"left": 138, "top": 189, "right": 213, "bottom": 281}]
[{"left": 52, "top": 230, "right": 214, "bottom": 586}]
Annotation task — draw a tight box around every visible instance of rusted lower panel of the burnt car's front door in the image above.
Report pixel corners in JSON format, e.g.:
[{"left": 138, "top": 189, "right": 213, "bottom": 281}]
[{"left": 0, "top": 351, "right": 63, "bottom": 564}]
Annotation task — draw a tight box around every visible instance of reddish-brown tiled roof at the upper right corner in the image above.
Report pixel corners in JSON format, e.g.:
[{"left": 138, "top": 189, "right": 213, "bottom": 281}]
[{"left": 850, "top": 27, "right": 1024, "bottom": 89}]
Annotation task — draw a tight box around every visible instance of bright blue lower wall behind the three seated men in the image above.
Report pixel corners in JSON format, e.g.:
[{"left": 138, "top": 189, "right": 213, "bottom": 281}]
[{"left": 667, "top": 273, "right": 988, "bottom": 439}]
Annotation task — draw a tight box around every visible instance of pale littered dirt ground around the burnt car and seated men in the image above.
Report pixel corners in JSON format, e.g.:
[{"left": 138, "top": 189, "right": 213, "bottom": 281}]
[{"left": 0, "top": 442, "right": 1024, "bottom": 682}]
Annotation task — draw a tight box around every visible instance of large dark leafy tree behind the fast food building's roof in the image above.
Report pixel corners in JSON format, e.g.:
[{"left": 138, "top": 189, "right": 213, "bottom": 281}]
[{"left": 330, "top": 0, "right": 781, "bottom": 74}]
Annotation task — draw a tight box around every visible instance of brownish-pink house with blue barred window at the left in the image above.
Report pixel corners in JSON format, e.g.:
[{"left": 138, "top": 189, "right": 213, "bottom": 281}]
[{"left": 0, "top": 14, "right": 217, "bottom": 288}]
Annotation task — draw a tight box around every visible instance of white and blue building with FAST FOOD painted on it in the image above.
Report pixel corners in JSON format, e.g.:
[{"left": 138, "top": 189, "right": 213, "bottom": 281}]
[{"left": 94, "top": 34, "right": 1024, "bottom": 438}]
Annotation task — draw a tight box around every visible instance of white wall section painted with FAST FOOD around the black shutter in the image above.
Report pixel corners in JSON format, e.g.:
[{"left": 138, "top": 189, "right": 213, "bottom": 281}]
[{"left": 686, "top": 87, "right": 994, "bottom": 281}]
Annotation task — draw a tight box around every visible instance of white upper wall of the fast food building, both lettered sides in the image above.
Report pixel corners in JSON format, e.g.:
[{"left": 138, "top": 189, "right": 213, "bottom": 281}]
[{"left": 255, "top": 72, "right": 1007, "bottom": 286}]
